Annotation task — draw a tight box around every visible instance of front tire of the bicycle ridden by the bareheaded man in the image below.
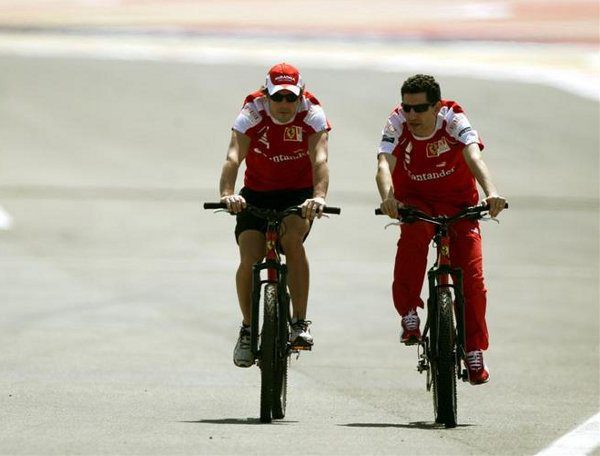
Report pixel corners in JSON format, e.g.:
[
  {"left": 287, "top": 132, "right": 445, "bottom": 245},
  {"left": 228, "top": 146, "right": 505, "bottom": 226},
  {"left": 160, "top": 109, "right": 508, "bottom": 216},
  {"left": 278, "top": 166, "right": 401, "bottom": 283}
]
[{"left": 432, "top": 288, "right": 457, "bottom": 428}]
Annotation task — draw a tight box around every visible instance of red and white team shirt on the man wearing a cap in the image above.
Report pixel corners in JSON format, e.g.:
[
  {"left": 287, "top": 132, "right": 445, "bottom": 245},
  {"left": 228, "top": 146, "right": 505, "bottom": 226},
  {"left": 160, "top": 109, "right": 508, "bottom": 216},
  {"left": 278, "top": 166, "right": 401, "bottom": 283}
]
[{"left": 233, "top": 91, "right": 331, "bottom": 191}]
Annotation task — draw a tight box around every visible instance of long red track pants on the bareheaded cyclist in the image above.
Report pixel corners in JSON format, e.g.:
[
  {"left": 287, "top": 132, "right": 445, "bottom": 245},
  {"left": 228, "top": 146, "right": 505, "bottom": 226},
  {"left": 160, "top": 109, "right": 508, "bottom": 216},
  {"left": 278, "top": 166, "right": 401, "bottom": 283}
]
[{"left": 392, "top": 201, "right": 488, "bottom": 351}]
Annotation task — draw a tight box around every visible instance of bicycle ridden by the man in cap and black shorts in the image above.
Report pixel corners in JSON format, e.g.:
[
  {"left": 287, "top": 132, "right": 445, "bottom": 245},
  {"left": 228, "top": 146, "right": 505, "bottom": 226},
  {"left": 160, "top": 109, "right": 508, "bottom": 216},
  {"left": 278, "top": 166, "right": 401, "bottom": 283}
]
[{"left": 204, "top": 202, "right": 341, "bottom": 423}]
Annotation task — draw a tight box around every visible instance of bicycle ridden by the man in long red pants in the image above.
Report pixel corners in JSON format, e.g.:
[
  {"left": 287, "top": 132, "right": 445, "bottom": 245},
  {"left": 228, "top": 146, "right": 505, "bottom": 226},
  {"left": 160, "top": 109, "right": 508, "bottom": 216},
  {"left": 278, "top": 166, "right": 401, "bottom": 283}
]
[{"left": 375, "top": 204, "right": 508, "bottom": 428}]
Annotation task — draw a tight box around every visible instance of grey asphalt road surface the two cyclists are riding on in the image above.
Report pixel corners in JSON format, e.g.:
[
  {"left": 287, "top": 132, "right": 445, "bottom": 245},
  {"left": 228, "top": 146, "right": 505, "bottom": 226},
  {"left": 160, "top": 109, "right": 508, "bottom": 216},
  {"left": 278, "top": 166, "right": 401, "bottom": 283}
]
[{"left": 0, "top": 57, "right": 600, "bottom": 455}]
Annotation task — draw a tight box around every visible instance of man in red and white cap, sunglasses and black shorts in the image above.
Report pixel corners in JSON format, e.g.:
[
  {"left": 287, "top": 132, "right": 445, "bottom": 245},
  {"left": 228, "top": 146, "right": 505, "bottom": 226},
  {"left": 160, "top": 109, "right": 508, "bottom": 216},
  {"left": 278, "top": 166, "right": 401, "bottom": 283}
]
[{"left": 220, "top": 63, "right": 331, "bottom": 367}]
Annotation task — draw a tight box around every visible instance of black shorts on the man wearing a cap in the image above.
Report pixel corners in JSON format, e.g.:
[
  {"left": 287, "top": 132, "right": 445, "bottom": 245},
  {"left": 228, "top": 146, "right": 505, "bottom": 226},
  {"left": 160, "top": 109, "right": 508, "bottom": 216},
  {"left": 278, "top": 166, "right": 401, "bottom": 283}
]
[{"left": 235, "top": 187, "right": 313, "bottom": 242}]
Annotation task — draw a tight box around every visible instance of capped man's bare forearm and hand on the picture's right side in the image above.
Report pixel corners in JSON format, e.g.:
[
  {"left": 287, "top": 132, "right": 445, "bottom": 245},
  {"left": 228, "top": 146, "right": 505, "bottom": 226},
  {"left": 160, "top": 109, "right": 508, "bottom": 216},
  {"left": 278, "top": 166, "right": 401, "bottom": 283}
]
[{"left": 302, "top": 130, "right": 329, "bottom": 220}]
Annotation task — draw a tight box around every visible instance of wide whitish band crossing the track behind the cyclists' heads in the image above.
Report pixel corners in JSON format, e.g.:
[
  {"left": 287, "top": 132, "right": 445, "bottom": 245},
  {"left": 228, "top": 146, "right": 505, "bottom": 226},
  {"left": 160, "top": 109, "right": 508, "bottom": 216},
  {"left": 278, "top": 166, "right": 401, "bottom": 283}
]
[{"left": 0, "top": 34, "right": 600, "bottom": 101}]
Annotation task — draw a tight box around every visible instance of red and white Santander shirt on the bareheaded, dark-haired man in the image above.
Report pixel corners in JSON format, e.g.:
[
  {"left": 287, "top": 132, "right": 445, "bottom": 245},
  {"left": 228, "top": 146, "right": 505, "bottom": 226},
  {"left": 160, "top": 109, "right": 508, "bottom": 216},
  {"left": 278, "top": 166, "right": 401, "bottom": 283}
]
[{"left": 378, "top": 100, "right": 484, "bottom": 206}]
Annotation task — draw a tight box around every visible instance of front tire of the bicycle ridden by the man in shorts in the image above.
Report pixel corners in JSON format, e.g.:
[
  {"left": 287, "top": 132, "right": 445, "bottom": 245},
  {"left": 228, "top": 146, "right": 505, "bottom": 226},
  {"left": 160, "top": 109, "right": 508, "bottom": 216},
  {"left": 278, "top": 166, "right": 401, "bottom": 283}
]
[{"left": 259, "top": 283, "right": 277, "bottom": 423}]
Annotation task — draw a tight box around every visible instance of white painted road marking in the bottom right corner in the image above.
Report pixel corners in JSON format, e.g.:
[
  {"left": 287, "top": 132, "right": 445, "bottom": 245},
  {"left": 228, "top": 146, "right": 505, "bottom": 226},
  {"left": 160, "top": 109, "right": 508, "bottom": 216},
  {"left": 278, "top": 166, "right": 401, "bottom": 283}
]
[{"left": 536, "top": 413, "right": 600, "bottom": 456}]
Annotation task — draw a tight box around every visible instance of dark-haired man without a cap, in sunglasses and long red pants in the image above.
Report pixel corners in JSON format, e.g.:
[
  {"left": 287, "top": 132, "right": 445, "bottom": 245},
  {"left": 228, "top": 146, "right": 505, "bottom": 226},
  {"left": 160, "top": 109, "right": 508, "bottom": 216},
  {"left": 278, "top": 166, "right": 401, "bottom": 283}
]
[{"left": 376, "top": 74, "right": 506, "bottom": 385}]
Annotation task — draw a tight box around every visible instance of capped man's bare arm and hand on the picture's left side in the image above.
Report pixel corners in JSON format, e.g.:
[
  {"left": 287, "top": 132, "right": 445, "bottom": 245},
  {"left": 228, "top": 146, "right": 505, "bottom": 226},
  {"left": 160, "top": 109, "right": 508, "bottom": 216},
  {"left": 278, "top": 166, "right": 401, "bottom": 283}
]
[{"left": 219, "top": 130, "right": 250, "bottom": 213}]
